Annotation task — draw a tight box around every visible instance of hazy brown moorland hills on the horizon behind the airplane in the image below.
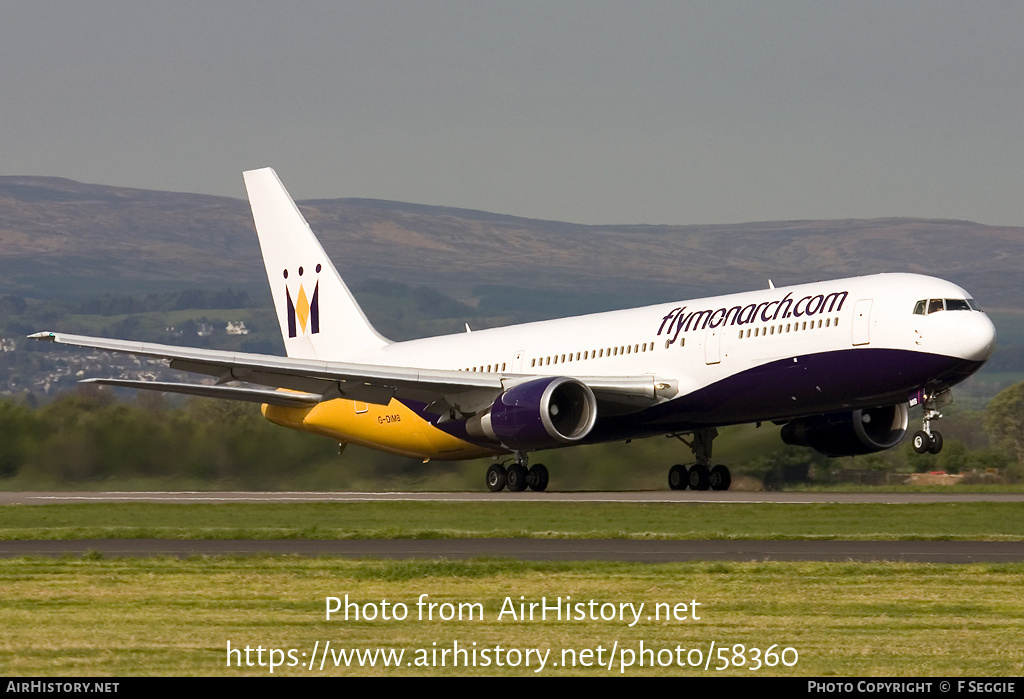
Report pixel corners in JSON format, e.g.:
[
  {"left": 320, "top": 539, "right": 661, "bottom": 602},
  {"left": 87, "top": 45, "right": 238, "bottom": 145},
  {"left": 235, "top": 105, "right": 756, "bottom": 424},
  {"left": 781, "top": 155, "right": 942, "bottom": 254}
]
[{"left": 0, "top": 176, "right": 1024, "bottom": 310}]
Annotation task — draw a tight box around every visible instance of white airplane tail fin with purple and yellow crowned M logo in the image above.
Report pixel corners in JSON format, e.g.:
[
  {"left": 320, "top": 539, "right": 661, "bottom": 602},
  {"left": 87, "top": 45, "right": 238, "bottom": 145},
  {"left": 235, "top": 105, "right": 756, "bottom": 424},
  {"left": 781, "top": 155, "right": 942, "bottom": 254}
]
[{"left": 242, "top": 168, "right": 388, "bottom": 361}]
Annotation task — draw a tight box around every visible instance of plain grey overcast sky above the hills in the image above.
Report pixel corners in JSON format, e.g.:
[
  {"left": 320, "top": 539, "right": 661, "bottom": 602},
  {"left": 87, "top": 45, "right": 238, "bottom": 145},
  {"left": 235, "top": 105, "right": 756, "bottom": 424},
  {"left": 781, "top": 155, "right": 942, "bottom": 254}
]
[{"left": 0, "top": 0, "right": 1024, "bottom": 225}]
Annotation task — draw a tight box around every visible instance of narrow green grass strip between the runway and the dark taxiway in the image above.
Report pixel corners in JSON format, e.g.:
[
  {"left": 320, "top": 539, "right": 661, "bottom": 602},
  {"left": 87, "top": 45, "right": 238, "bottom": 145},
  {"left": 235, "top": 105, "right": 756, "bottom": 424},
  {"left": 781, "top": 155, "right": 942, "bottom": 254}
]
[{"left": 0, "top": 501, "right": 1024, "bottom": 540}]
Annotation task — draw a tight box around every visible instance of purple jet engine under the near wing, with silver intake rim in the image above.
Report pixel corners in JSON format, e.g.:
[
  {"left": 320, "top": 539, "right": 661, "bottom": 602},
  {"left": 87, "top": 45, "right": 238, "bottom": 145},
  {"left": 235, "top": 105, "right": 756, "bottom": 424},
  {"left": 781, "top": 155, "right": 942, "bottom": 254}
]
[{"left": 466, "top": 377, "right": 597, "bottom": 451}]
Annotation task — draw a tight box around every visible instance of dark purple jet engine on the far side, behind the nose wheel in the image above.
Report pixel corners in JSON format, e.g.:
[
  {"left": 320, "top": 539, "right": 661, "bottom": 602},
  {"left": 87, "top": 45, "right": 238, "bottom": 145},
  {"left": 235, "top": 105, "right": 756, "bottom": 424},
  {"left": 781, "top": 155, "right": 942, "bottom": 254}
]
[{"left": 782, "top": 403, "right": 907, "bottom": 456}]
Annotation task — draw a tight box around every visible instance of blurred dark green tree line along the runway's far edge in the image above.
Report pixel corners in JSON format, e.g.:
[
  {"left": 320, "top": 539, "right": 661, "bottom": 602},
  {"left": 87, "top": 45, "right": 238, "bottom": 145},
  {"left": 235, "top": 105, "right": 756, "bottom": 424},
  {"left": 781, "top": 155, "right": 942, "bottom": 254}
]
[{"left": 0, "top": 382, "right": 1024, "bottom": 489}]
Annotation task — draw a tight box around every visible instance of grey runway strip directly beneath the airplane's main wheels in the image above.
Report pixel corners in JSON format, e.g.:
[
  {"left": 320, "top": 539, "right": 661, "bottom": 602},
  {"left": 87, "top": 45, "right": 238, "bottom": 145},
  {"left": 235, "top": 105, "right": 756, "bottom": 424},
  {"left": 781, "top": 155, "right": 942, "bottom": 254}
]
[{"left": 0, "top": 490, "right": 1024, "bottom": 505}]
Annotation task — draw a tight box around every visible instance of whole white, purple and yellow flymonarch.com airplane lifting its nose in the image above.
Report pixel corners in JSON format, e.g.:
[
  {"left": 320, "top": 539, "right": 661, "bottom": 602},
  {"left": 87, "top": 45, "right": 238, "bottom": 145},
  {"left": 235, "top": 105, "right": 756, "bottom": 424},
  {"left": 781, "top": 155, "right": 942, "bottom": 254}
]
[{"left": 31, "top": 168, "right": 995, "bottom": 491}]
